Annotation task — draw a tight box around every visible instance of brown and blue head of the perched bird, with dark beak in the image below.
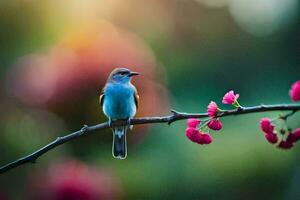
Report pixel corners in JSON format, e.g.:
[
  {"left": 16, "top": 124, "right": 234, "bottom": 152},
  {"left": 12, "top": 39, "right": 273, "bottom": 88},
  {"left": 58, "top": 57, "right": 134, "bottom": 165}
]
[{"left": 108, "top": 68, "right": 139, "bottom": 83}]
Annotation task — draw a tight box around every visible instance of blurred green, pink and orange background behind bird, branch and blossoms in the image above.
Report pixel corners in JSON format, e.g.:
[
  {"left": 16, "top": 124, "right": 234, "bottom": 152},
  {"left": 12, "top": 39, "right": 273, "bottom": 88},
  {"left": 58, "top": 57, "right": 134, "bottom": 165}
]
[{"left": 0, "top": 0, "right": 300, "bottom": 200}]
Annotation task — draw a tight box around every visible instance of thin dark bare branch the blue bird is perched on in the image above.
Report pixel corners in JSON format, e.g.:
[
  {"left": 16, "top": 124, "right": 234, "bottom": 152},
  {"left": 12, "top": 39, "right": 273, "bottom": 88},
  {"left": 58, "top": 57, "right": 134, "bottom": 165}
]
[{"left": 0, "top": 104, "right": 300, "bottom": 174}]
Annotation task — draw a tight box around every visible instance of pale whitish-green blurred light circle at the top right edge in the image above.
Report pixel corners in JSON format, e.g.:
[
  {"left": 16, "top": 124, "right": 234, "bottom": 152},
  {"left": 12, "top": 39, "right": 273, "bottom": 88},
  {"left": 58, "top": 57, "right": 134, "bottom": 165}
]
[{"left": 229, "top": 0, "right": 299, "bottom": 36}]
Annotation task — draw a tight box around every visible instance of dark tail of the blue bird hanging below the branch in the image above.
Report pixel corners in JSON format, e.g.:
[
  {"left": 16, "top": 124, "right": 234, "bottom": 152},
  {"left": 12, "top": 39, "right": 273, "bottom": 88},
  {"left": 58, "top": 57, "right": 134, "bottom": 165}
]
[{"left": 112, "top": 126, "right": 127, "bottom": 159}]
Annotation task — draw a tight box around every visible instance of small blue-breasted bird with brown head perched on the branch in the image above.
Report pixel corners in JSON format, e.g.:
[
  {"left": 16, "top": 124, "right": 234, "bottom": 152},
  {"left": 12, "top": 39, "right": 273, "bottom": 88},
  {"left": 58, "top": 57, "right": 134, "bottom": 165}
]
[{"left": 99, "top": 68, "right": 139, "bottom": 159}]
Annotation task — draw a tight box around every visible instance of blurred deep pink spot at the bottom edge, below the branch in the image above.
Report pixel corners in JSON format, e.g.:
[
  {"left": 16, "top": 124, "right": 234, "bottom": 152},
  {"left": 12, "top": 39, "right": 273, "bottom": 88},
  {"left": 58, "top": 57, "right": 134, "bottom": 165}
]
[{"left": 26, "top": 160, "right": 120, "bottom": 200}]
